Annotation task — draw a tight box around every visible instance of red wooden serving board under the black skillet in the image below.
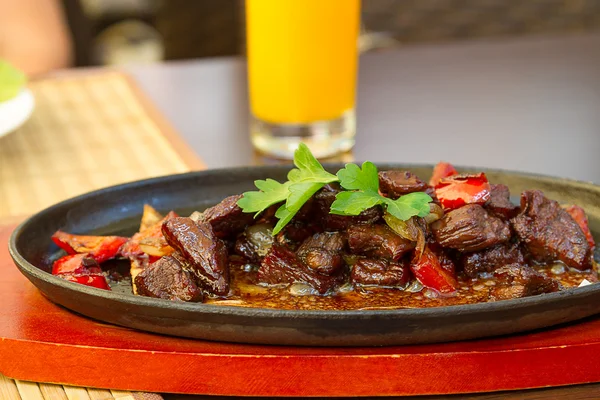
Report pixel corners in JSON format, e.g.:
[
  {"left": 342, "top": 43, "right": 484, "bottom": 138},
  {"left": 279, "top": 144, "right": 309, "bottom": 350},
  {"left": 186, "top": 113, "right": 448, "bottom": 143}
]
[{"left": 0, "top": 226, "right": 600, "bottom": 396}]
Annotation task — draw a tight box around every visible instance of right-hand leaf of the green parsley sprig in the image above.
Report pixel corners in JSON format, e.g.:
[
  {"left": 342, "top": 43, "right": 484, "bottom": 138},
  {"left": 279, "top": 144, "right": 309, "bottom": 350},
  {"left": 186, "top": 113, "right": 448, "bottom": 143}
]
[{"left": 330, "top": 161, "right": 432, "bottom": 221}]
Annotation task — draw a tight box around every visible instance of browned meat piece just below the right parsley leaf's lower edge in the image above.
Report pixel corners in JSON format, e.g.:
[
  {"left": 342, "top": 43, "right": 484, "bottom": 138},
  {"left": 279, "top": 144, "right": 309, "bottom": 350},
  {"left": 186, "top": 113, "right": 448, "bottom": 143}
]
[{"left": 348, "top": 225, "right": 416, "bottom": 261}]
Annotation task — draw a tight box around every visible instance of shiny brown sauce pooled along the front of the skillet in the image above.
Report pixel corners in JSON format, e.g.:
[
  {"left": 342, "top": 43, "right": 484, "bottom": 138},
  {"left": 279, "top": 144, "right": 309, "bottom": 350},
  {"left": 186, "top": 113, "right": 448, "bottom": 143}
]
[{"left": 205, "top": 264, "right": 598, "bottom": 311}]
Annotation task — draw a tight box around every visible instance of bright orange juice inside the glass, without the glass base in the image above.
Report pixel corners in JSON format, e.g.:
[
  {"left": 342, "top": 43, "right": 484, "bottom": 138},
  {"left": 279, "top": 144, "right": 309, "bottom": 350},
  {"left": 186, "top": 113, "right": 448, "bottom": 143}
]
[{"left": 246, "top": 0, "right": 360, "bottom": 124}]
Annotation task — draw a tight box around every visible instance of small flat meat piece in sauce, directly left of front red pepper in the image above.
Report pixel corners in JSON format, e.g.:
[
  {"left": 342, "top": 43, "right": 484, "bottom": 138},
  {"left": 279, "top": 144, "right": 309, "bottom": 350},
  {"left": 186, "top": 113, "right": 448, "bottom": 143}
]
[{"left": 350, "top": 259, "right": 410, "bottom": 287}]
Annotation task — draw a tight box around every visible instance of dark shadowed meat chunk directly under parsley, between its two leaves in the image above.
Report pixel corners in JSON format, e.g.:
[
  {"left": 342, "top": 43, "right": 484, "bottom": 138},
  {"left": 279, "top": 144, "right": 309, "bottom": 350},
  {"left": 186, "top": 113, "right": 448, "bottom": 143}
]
[{"left": 309, "top": 183, "right": 383, "bottom": 231}]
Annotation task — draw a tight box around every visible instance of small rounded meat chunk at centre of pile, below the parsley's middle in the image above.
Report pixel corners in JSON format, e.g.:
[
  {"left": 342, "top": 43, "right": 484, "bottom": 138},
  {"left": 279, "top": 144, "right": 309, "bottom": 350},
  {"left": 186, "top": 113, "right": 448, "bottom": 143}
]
[{"left": 296, "top": 232, "right": 345, "bottom": 275}]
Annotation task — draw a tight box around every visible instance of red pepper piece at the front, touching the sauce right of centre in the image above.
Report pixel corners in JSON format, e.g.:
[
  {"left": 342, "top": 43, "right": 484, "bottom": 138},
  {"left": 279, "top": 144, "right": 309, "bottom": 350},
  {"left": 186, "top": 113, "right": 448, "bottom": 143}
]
[{"left": 410, "top": 246, "right": 458, "bottom": 294}]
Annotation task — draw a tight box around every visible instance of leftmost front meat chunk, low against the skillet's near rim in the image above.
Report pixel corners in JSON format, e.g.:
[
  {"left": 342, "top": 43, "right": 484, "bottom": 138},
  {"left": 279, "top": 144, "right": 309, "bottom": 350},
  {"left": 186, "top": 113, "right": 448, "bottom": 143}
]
[{"left": 135, "top": 256, "right": 203, "bottom": 301}]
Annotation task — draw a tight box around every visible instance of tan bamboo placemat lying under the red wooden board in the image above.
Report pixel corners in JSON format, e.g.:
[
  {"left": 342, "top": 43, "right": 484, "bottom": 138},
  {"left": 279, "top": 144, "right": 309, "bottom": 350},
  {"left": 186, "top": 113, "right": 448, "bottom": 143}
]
[{"left": 0, "top": 71, "right": 203, "bottom": 400}]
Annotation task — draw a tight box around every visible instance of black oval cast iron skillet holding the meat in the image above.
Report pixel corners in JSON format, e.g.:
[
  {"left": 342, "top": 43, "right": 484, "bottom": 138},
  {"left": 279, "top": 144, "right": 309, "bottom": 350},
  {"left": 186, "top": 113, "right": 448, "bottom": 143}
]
[{"left": 9, "top": 164, "right": 600, "bottom": 346}]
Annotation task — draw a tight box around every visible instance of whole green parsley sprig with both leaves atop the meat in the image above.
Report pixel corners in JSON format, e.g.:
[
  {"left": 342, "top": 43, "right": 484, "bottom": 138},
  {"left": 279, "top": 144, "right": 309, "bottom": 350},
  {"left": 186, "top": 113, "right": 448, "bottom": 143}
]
[{"left": 237, "top": 144, "right": 432, "bottom": 235}]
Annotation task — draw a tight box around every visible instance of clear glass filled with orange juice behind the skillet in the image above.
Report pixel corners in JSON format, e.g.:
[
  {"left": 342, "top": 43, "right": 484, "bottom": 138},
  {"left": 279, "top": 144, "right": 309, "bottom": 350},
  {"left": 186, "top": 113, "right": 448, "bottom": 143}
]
[{"left": 246, "top": 0, "right": 360, "bottom": 158}]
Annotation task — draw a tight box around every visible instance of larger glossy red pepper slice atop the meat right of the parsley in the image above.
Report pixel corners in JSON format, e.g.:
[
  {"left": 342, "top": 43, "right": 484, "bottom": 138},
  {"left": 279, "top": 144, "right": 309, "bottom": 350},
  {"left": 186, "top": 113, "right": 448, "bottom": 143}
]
[{"left": 435, "top": 172, "right": 491, "bottom": 210}]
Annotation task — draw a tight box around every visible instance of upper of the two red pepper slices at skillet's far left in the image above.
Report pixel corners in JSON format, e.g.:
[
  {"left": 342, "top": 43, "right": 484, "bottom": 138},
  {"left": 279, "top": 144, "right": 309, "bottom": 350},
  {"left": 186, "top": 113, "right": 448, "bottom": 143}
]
[{"left": 52, "top": 231, "right": 129, "bottom": 263}]
